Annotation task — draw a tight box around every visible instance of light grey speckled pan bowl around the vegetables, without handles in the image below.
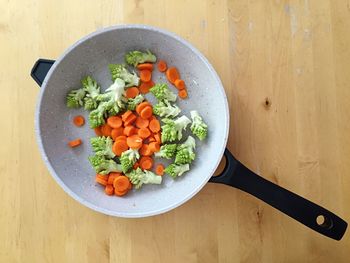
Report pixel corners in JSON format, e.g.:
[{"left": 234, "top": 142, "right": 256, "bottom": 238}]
[{"left": 36, "top": 25, "right": 229, "bottom": 217}]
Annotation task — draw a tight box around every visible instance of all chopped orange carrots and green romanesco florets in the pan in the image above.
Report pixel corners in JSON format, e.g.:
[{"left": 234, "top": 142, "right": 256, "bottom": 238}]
[{"left": 66, "top": 51, "right": 208, "bottom": 196}]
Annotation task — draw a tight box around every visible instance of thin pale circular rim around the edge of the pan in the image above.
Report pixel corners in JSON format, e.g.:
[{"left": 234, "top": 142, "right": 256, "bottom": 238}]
[{"left": 34, "top": 24, "right": 230, "bottom": 218}]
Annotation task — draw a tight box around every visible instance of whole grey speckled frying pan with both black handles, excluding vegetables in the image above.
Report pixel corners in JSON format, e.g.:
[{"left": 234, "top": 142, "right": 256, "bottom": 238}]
[{"left": 31, "top": 25, "right": 347, "bottom": 240}]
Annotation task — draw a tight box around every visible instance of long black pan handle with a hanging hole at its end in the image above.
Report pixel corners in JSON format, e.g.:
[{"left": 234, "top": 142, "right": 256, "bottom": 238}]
[{"left": 209, "top": 149, "right": 348, "bottom": 240}]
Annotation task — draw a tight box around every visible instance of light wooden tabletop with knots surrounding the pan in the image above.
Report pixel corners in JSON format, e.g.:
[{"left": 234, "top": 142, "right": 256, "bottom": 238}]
[{"left": 0, "top": 0, "right": 350, "bottom": 263}]
